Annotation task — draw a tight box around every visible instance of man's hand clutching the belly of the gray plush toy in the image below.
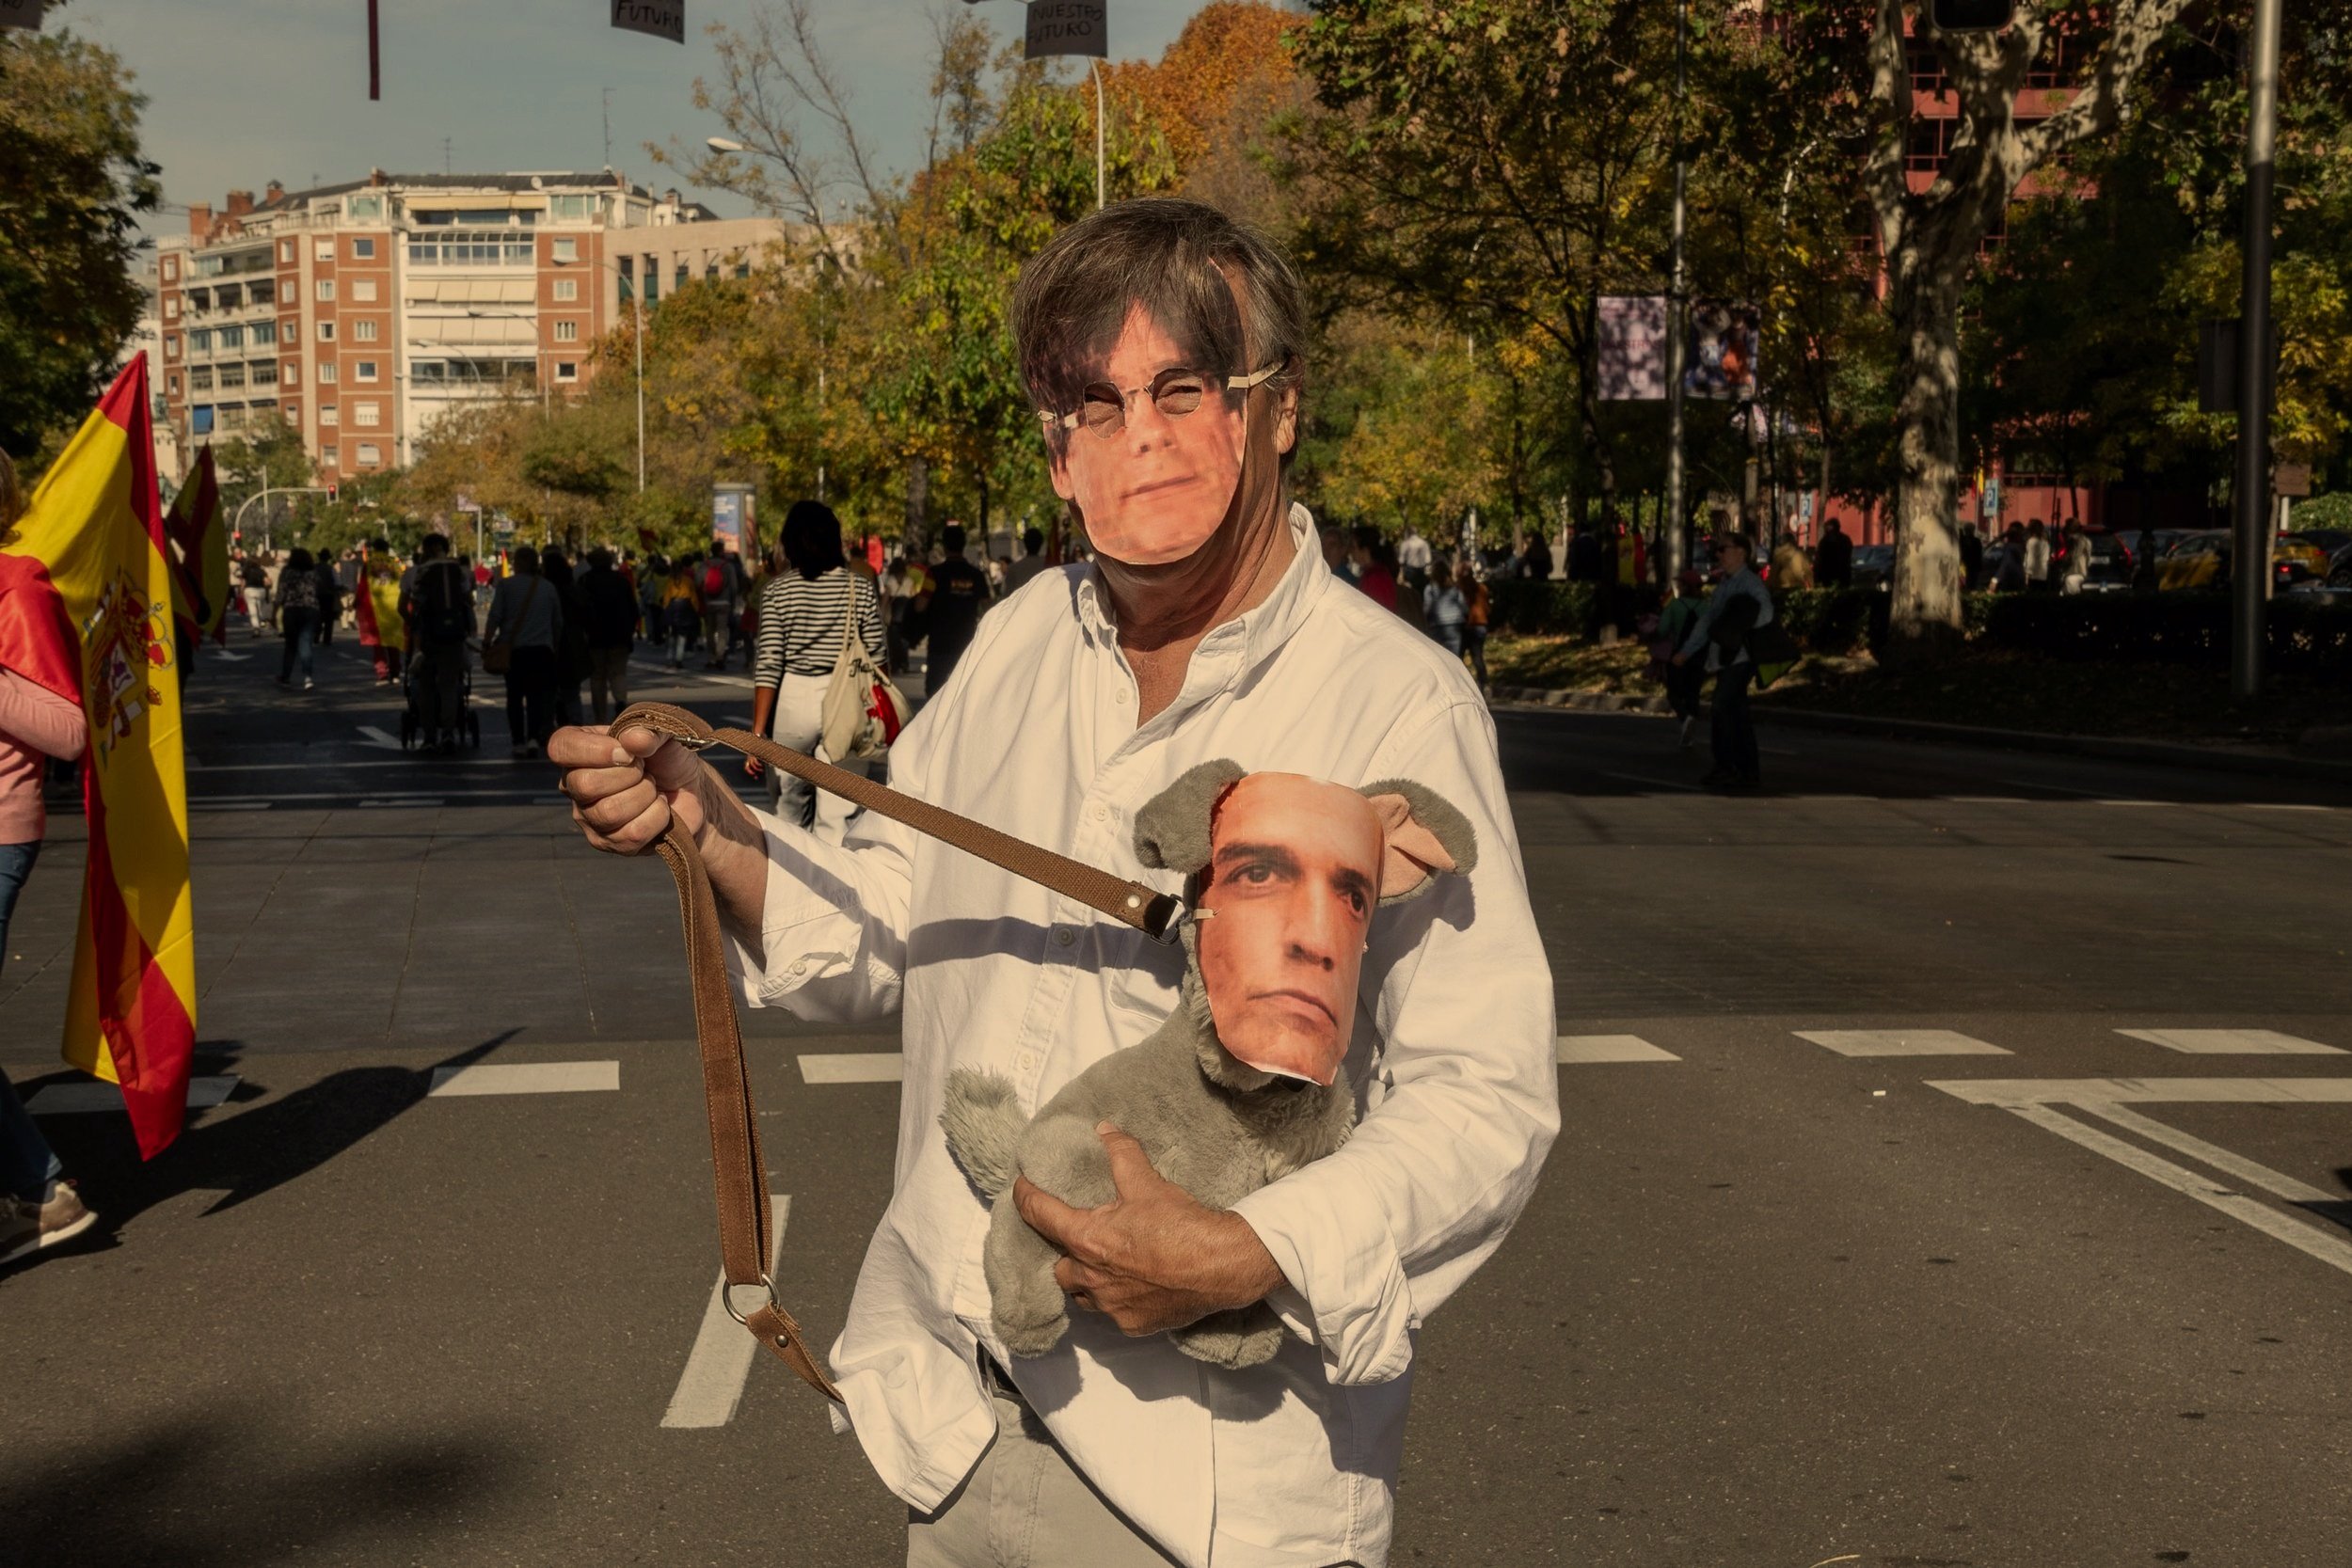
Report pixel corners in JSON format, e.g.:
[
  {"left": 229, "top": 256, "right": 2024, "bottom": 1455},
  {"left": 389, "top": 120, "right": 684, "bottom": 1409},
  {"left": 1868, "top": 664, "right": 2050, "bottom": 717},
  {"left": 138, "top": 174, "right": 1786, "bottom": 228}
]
[{"left": 1014, "top": 1121, "right": 1282, "bottom": 1336}]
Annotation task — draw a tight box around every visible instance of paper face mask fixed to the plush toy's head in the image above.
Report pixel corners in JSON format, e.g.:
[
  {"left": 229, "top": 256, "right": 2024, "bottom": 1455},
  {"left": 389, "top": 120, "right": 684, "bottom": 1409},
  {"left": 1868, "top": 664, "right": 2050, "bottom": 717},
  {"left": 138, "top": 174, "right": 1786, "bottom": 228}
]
[{"left": 1198, "top": 773, "right": 1386, "bottom": 1086}]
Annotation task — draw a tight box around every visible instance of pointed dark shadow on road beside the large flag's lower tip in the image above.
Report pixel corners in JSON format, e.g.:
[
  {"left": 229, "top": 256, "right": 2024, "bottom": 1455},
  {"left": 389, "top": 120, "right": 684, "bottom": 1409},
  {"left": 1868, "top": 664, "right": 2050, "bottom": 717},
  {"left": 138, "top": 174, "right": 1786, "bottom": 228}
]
[{"left": 19, "top": 1030, "right": 520, "bottom": 1251}]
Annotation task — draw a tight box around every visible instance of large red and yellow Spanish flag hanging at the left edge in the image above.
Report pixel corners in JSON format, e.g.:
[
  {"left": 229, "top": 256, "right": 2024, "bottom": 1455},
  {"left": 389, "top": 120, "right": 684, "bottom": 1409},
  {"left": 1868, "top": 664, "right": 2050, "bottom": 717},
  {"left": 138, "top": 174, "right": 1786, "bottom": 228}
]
[{"left": 9, "top": 355, "right": 196, "bottom": 1159}]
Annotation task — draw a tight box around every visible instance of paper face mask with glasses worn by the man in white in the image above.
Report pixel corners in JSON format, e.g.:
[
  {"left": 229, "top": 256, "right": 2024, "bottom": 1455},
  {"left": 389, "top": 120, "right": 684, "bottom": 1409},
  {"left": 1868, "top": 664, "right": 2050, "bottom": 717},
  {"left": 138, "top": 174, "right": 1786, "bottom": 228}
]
[{"left": 1052, "top": 308, "right": 1278, "bottom": 566}]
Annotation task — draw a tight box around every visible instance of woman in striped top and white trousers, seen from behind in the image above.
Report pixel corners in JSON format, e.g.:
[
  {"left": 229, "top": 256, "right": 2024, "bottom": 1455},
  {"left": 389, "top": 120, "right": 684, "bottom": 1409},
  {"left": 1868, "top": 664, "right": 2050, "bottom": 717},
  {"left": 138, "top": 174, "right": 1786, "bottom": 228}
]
[{"left": 743, "top": 500, "right": 882, "bottom": 844}]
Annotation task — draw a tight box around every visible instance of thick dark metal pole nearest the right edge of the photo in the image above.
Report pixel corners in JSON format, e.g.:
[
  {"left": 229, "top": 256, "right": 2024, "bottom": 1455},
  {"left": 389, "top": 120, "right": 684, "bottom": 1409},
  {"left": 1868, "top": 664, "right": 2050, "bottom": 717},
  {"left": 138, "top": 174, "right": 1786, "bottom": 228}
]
[{"left": 2230, "top": 0, "right": 2280, "bottom": 701}]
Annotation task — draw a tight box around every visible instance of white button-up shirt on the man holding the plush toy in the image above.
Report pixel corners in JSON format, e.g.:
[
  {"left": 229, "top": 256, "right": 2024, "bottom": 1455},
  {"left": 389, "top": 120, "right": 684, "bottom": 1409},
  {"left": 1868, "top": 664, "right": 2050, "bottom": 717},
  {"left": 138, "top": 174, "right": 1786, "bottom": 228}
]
[{"left": 729, "top": 508, "right": 1560, "bottom": 1568}]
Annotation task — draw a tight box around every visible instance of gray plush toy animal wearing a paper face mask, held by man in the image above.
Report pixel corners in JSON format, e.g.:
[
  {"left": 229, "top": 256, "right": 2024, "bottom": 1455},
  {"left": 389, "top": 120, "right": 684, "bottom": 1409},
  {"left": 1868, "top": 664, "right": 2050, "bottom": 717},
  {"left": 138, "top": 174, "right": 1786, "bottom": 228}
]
[{"left": 939, "top": 762, "right": 1477, "bottom": 1369}]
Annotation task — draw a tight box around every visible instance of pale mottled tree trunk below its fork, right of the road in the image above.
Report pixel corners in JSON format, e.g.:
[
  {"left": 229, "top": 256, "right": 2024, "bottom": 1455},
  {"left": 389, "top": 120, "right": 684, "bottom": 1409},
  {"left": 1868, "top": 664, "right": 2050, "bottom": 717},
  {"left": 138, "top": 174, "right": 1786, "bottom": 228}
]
[{"left": 1886, "top": 270, "right": 1962, "bottom": 665}]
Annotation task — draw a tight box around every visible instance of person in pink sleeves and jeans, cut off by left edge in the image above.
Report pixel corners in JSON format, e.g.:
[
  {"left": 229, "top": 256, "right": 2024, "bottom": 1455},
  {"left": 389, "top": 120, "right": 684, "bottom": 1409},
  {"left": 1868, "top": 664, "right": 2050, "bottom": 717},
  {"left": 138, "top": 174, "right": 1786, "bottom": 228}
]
[{"left": 0, "top": 453, "right": 99, "bottom": 1265}]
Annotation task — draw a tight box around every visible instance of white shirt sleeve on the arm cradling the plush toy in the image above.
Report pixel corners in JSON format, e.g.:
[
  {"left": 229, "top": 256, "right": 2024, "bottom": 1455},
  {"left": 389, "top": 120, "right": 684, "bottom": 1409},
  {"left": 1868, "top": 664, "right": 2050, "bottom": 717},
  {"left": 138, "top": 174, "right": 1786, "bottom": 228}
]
[{"left": 1235, "top": 703, "right": 1560, "bottom": 1385}]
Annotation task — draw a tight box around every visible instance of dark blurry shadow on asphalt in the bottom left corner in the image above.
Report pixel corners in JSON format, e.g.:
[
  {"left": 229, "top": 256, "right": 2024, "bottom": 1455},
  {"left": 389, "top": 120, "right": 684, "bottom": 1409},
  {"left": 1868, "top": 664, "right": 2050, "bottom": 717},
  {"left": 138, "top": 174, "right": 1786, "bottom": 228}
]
[{"left": 0, "top": 1408, "right": 530, "bottom": 1568}]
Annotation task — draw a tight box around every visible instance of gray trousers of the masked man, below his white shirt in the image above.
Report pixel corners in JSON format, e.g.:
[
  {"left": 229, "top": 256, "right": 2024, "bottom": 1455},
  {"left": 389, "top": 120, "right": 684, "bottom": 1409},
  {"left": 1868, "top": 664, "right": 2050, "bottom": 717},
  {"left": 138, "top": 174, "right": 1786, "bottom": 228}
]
[{"left": 906, "top": 1392, "right": 1176, "bottom": 1568}]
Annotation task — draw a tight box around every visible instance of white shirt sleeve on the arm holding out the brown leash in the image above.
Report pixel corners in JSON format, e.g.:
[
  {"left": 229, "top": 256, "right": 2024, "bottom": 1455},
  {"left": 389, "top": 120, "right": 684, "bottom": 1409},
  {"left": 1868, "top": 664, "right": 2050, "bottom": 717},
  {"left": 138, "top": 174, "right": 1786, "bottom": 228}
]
[{"left": 727, "top": 715, "right": 930, "bottom": 1022}]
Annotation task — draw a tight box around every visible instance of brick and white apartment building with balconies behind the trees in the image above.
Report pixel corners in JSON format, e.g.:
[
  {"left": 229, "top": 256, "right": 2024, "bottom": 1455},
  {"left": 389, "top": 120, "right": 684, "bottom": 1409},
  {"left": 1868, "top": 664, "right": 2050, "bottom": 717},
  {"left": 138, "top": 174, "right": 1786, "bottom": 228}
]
[{"left": 155, "top": 169, "right": 784, "bottom": 482}]
